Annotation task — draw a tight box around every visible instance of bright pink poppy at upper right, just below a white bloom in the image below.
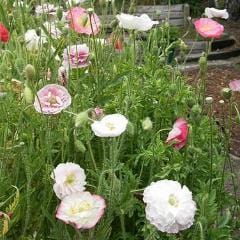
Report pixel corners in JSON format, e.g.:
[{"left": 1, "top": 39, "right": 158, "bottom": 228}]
[{"left": 194, "top": 18, "right": 224, "bottom": 38}]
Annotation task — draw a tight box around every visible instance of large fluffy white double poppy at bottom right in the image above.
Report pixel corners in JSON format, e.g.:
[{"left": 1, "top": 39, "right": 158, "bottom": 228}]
[{"left": 143, "top": 180, "right": 196, "bottom": 233}]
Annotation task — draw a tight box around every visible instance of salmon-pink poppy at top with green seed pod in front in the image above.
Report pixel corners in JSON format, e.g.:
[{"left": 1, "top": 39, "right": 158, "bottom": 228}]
[{"left": 67, "top": 7, "right": 100, "bottom": 35}]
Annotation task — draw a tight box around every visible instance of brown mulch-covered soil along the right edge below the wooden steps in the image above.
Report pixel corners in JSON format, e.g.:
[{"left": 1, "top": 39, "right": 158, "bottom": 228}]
[{"left": 185, "top": 66, "right": 240, "bottom": 157}]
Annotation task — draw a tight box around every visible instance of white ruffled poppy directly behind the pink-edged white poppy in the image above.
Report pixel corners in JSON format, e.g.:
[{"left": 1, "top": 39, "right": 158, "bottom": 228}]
[{"left": 51, "top": 162, "right": 86, "bottom": 199}]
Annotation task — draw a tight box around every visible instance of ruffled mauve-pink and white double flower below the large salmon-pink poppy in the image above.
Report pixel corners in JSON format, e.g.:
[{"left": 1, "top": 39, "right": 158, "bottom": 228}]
[{"left": 63, "top": 44, "right": 89, "bottom": 69}]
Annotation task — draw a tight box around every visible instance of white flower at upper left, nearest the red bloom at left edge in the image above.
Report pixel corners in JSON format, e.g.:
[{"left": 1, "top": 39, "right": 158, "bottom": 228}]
[{"left": 24, "top": 29, "right": 46, "bottom": 51}]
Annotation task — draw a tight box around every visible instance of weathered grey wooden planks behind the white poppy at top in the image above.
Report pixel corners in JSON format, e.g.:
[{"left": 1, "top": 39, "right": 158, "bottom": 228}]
[{"left": 100, "top": 4, "right": 190, "bottom": 28}]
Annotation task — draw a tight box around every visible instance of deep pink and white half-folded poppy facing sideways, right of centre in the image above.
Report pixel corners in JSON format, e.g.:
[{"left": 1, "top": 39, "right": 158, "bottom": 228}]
[{"left": 166, "top": 118, "right": 188, "bottom": 149}]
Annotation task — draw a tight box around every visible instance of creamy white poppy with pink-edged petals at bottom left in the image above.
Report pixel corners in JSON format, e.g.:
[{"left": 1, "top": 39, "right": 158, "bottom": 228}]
[{"left": 56, "top": 192, "right": 106, "bottom": 229}]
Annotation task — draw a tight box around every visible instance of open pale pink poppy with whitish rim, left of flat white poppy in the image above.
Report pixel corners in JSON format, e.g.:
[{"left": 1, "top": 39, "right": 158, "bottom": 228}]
[{"left": 34, "top": 84, "right": 72, "bottom": 114}]
